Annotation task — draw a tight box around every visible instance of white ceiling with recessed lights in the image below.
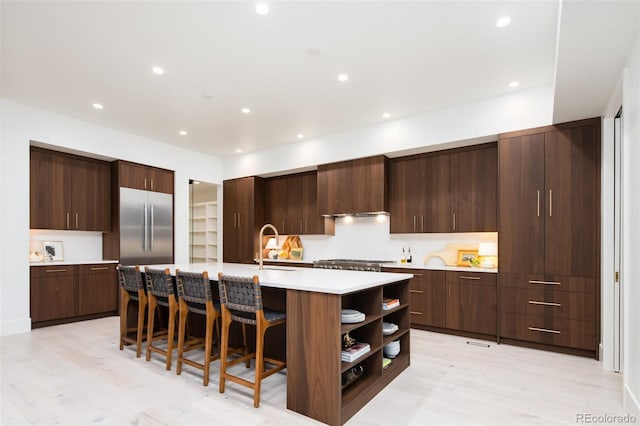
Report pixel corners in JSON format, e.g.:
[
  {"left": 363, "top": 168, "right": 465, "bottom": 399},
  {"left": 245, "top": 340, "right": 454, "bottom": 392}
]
[{"left": 1, "top": 0, "right": 640, "bottom": 157}]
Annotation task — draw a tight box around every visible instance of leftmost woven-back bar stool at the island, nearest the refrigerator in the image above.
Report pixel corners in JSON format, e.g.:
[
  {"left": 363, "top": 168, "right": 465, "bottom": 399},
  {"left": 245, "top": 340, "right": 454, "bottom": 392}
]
[{"left": 118, "top": 265, "right": 147, "bottom": 358}]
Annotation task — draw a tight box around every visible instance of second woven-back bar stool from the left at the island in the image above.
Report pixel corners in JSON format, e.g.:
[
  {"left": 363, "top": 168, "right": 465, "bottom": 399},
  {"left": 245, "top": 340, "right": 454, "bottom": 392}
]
[{"left": 144, "top": 266, "right": 178, "bottom": 370}]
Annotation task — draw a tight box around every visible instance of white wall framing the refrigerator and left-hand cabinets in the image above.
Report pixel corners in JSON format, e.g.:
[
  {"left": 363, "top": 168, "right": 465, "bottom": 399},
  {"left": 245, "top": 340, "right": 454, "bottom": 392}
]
[{"left": 0, "top": 99, "right": 222, "bottom": 335}]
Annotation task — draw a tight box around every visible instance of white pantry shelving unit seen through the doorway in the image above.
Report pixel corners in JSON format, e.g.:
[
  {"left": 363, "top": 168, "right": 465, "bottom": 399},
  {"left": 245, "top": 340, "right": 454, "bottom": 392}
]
[{"left": 190, "top": 201, "right": 218, "bottom": 263}]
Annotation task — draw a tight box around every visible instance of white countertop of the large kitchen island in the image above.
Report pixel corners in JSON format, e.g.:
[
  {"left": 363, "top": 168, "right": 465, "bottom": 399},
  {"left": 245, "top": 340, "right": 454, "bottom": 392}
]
[{"left": 140, "top": 263, "right": 413, "bottom": 294}]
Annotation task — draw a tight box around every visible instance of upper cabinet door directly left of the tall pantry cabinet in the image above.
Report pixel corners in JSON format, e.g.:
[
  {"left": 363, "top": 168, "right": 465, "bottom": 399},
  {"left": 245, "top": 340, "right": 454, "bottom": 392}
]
[{"left": 451, "top": 147, "right": 498, "bottom": 232}]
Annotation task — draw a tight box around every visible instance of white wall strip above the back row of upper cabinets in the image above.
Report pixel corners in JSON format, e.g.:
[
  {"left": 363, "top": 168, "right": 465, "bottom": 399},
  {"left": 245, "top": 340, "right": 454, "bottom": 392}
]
[{"left": 224, "top": 87, "right": 553, "bottom": 179}]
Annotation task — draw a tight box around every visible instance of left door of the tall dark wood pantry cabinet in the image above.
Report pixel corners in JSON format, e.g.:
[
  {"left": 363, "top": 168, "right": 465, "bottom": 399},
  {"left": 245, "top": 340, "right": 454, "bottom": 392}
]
[{"left": 498, "top": 133, "right": 545, "bottom": 274}]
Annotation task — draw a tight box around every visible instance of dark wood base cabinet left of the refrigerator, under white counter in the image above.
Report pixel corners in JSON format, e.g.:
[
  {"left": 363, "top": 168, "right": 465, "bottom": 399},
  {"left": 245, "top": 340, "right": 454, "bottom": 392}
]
[{"left": 30, "top": 263, "right": 118, "bottom": 328}]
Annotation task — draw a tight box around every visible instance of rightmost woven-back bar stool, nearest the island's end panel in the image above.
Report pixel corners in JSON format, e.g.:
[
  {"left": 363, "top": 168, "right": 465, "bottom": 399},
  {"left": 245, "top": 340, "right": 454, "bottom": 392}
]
[{"left": 218, "top": 272, "right": 287, "bottom": 408}]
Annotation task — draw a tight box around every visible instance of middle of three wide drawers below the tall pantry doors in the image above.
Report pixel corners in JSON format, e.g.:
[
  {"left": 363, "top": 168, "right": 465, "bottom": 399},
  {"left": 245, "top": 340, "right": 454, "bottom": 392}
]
[{"left": 500, "top": 287, "right": 596, "bottom": 322}]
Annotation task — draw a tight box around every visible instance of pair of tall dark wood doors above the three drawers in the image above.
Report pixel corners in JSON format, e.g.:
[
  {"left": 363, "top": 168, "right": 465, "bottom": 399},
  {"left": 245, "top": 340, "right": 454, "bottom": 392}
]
[{"left": 498, "top": 119, "right": 600, "bottom": 277}]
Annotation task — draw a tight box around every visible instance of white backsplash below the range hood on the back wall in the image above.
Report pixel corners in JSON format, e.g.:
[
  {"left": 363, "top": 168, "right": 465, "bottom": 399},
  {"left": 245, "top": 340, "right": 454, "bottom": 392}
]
[{"left": 300, "top": 216, "right": 498, "bottom": 264}]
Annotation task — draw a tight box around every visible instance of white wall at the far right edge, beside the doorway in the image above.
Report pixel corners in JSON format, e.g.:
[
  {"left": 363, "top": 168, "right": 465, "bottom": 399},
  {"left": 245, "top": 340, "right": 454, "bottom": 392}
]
[{"left": 622, "top": 28, "right": 640, "bottom": 413}]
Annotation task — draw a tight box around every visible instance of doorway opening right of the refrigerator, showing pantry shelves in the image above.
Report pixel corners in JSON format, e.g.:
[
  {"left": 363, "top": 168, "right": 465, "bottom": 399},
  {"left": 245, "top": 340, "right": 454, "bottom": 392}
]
[{"left": 189, "top": 179, "right": 220, "bottom": 263}]
